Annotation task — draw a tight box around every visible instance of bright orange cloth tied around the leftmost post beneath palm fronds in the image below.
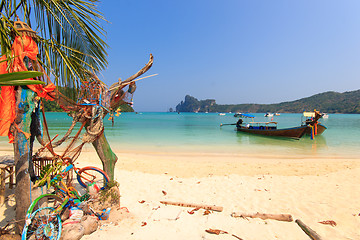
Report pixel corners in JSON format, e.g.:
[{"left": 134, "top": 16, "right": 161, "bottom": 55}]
[{"left": 0, "top": 36, "right": 55, "bottom": 143}]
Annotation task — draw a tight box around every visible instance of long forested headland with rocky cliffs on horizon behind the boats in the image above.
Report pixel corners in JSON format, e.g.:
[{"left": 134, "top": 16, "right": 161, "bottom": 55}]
[{"left": 176, "top": 90, "right": 360, "bottom": 114}]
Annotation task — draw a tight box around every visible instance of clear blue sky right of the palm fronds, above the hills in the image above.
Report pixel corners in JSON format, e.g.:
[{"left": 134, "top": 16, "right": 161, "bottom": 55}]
[{"left": 99, "top": 0, "right": 360, "bottom": 111}]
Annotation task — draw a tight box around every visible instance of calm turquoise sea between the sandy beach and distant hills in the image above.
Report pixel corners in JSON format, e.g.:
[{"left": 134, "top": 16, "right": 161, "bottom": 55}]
[{"left": 0, "top": 112, "right": 360, "bottom": 158}]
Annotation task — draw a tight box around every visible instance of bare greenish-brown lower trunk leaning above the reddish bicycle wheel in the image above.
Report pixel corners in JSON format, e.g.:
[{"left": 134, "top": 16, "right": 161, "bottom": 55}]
[{"left": 92, "top": 132, "right": 118, "bottom": 180}]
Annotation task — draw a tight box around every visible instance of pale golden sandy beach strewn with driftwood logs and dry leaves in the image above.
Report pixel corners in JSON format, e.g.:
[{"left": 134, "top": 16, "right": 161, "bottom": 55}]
[{"left": 0, "top": 149, "right": 360, "bottom": 240}]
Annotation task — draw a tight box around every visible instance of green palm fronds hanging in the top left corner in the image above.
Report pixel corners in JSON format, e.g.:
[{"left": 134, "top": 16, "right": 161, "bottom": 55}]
[{"left": 0, "top": 0, "right": 107, "bottom": 86}]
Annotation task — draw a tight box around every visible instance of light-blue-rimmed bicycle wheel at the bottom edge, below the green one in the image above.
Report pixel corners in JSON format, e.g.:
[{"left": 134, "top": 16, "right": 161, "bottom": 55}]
[{"left": 21, "top": 207, "right": 61, "bottom": 240}]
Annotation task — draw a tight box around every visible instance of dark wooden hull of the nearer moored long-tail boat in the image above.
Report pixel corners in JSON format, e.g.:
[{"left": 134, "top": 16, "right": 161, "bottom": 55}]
[{"left": 236, "top": 126, "right": 309, "bottom": 139}]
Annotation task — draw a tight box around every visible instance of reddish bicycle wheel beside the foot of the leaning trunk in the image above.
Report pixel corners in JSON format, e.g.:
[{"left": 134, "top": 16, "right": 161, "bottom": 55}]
[{"left": 77, "top": 167, "right": 109, "bottom": 190}]
